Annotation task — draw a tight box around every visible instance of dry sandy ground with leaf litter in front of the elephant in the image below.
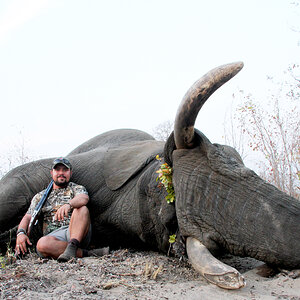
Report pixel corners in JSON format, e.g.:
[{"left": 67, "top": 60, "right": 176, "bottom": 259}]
[{"left": 0, "top": 249, "right": 300, "bottom": 300}]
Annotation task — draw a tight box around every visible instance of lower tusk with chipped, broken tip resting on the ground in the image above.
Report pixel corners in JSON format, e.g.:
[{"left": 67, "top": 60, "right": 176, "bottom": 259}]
[{"left": 186, "top": 237, "right": 246, "bottom": 290}]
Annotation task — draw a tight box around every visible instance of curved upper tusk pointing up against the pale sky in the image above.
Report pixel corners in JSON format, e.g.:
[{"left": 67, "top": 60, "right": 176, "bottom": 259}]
[{"left": 174, "top": 62, "right": 244, "bottom": 149}]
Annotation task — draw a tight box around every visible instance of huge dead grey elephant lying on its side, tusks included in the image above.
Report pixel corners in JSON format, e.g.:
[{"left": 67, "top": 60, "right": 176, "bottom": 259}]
[{"left": 0, "top": 62, "right": 300, "bottom": 289}]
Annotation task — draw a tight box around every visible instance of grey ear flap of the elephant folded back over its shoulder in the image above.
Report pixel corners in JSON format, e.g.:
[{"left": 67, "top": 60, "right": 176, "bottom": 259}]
[{"left": 103, "top": 140, "right": 164, "bottom": 191}]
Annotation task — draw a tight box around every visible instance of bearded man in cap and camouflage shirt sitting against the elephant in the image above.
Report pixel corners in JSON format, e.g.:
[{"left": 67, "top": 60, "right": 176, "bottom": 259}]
[{"left": 15, "top": 157, "right": 108, "bottom": 262}]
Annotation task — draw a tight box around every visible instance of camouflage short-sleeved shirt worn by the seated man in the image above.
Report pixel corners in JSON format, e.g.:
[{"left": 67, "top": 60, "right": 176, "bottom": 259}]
[{"left": 27, "top": 182, "right": 88, "bottom": 235}]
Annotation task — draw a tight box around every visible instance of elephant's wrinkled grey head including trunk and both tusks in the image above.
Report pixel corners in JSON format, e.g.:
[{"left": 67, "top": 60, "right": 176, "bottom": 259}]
[{"left": 167, "top": 63, "right": 300, "bottom": 288}]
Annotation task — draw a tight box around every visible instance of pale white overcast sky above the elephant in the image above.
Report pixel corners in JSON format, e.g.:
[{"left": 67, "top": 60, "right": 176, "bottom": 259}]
[{"left": 0, "top": 0, "right": 300, "bottom": 169}]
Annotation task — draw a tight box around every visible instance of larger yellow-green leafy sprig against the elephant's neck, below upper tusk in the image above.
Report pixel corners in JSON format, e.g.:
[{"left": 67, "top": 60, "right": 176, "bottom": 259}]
[{"left": 156, "top": 155, "right": 175, "bottom": 203}]
